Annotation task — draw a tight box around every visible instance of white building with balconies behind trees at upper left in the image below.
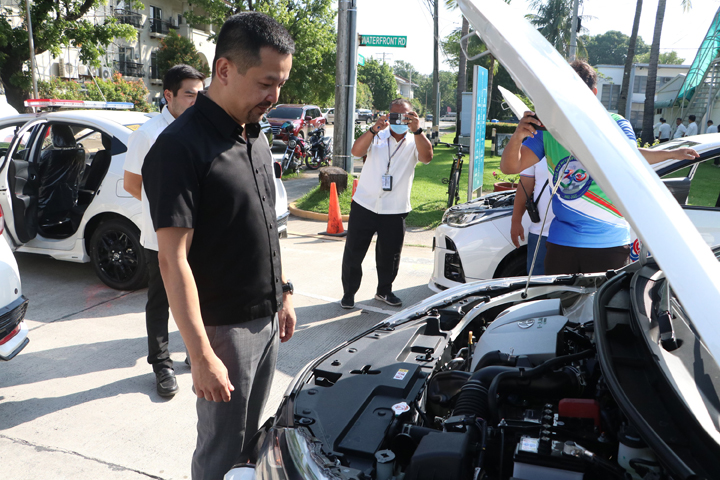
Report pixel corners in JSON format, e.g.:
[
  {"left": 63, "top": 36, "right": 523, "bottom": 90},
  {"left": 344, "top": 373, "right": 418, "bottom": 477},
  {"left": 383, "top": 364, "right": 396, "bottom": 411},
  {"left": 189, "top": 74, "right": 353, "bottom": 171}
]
[{"left": 0, "top": 0, "right": 215, "bottom": 103}]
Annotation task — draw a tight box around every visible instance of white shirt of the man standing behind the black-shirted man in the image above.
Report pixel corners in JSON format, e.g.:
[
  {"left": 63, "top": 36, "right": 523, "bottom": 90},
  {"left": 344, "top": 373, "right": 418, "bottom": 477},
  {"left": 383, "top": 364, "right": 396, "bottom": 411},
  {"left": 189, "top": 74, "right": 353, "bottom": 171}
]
[{"left": 125, "top": 107, "right": 175, "bottom": 251}]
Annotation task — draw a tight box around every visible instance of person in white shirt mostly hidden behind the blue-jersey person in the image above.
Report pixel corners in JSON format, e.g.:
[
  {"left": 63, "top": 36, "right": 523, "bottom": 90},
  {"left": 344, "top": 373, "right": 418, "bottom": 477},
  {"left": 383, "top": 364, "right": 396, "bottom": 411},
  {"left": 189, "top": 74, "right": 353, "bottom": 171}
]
[{"left": 510, "top": 157, "right": 555, "bottom": 275}]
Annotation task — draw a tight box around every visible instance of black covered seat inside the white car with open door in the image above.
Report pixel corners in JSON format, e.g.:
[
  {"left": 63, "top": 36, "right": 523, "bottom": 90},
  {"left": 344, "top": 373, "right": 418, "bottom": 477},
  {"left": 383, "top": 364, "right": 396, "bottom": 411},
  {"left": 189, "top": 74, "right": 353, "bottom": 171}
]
[{"left": 38, "top": 125, "right": 85, "bottom": 229}]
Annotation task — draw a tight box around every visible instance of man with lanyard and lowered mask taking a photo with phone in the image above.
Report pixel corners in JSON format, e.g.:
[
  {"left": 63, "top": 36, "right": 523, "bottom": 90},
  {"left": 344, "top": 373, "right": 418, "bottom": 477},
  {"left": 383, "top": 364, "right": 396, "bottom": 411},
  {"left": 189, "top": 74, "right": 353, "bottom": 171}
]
[{"left": 340, "top": 98, "right": 433, "bottom": 308}]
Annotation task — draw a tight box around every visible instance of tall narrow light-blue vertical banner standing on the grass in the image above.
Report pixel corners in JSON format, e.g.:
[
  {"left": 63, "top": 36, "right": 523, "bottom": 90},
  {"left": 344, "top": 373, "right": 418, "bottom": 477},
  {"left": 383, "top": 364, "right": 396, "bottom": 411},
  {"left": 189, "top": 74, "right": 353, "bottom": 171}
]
[{"left": 468, "top": 65, "right": 488, "bottom": 202}]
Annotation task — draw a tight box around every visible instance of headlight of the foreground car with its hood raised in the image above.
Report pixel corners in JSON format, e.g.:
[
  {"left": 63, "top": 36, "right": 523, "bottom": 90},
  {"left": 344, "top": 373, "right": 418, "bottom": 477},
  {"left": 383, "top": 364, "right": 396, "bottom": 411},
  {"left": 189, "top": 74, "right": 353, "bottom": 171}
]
[{"left": 255, "top": 427, "right": 339, "bottom": 480}]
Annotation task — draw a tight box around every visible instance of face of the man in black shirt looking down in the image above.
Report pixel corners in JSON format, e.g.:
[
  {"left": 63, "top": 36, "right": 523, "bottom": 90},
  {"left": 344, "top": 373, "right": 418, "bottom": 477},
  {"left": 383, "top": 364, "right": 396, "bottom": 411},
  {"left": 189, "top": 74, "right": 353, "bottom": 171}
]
[{"left": 227, "top": 47, "right": 292, "bottom": 124}]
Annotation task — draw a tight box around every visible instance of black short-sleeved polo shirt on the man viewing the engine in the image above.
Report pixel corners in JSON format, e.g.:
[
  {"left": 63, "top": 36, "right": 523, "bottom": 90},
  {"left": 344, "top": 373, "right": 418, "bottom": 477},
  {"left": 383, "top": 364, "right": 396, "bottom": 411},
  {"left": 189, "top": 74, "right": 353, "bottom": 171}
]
[{"left": 142, "top": 94, "right": 282, "bottom": 325}]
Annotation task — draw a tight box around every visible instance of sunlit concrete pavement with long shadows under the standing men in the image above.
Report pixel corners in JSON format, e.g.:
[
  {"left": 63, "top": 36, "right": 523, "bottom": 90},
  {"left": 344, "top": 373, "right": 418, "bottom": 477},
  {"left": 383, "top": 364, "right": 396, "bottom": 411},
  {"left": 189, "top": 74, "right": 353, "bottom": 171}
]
[{"left": 0, "top": 219, "right": 432, "bottom": 480}]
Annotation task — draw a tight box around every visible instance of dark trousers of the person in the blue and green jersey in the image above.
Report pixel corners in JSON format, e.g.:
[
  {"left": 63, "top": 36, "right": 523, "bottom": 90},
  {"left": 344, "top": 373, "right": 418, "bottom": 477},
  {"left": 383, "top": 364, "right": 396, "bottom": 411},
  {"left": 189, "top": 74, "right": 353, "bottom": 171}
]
[{"left": 545, "top": 242, "right": 630, "bottom": 275}]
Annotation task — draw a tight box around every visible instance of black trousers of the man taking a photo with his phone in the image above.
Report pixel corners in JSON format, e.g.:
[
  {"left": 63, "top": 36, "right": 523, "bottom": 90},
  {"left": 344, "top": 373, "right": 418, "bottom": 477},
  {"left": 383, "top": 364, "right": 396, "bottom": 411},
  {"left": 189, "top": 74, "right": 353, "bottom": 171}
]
[{"left": 342, "top": 202, "right": 407, "bottom": 295}]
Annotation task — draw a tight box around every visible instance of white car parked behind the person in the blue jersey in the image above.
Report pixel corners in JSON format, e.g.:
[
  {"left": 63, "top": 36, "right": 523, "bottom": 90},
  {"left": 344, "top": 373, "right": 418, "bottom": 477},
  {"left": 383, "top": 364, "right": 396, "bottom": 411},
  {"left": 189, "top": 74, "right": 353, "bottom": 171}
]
[{"left": 428, "top": 133, "right": 720, "bottom": 292}]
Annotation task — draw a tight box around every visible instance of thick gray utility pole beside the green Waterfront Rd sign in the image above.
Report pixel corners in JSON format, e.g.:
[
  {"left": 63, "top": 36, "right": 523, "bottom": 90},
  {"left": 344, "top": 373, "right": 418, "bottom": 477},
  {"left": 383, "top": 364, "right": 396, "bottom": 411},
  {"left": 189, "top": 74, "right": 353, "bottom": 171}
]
[{"left": 333, "top": 0, "right": 352, "bottom": 169}]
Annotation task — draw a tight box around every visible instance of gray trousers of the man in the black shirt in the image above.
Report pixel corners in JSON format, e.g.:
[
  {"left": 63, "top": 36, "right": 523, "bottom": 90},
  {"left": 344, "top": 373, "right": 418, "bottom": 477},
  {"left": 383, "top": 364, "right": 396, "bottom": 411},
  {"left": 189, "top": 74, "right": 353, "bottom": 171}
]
[{"left": 192, "top": 315, "right": 279, "bottom": 480}]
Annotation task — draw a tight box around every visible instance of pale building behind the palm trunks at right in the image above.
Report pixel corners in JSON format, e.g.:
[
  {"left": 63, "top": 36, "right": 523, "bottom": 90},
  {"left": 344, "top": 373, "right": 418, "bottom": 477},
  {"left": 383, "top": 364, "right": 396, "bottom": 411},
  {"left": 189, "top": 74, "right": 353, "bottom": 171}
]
[{"left": 595, "top": 63, "right": 690, "bottom": 131}]
